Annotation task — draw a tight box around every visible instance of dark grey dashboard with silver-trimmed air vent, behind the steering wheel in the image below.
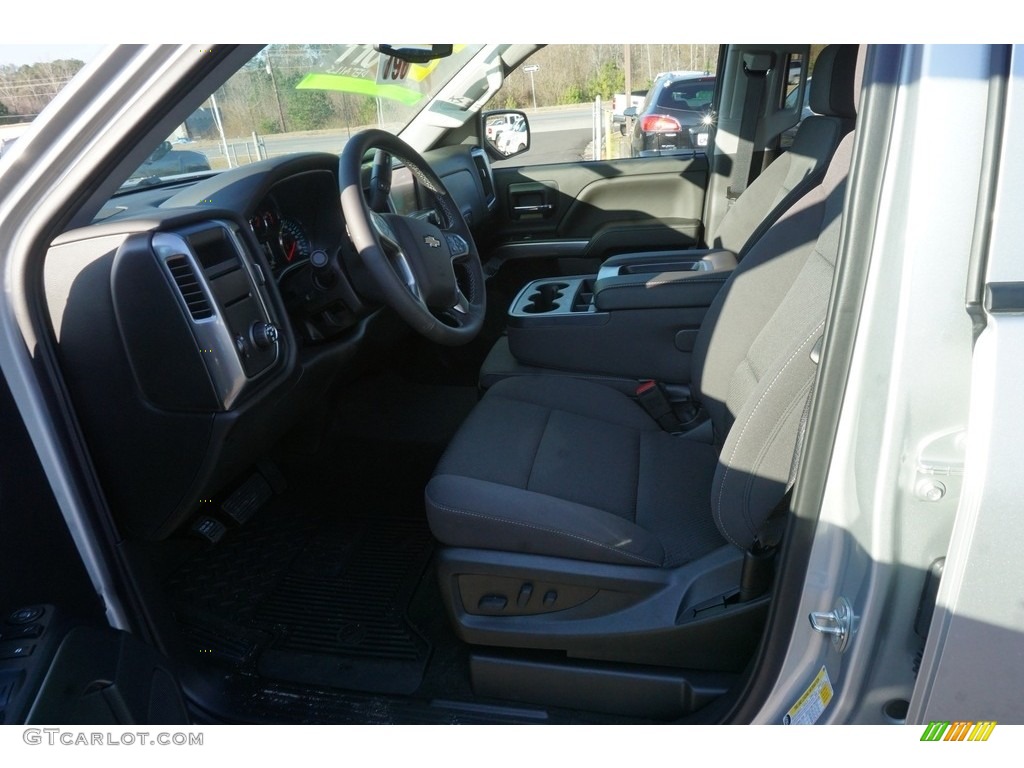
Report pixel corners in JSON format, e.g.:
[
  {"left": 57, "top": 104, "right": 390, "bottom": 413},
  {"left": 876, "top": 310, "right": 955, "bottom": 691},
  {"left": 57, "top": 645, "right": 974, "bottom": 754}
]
[{"left": 43, "top": 147, "right": 494, "bottom": 541}]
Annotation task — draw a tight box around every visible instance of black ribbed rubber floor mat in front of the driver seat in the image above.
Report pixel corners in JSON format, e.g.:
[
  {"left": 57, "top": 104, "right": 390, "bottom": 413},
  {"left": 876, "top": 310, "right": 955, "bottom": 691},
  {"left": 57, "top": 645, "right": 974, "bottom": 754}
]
[{"left": 168, "top": 499, "right": 431, "bottom": 694}]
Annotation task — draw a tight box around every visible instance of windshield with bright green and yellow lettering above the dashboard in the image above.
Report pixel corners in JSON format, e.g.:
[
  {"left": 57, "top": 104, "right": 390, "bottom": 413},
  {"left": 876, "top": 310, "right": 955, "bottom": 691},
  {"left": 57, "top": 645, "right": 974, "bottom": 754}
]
[{"left": 117, "top": 44, "right": 482, "bottom": 188}]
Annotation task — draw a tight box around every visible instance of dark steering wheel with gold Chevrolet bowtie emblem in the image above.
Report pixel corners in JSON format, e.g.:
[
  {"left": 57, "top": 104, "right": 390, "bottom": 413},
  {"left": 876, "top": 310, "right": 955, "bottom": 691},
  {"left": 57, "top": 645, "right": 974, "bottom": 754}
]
[{"left": 339, "top": 129, "right": 486, "bottom": 346}]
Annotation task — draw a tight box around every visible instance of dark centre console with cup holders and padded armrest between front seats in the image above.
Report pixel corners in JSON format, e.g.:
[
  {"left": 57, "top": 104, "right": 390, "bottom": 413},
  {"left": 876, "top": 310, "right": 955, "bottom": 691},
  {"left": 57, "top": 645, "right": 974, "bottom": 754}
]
[{"left": 480, "top": 250, "right": 736, "bottom": 392}]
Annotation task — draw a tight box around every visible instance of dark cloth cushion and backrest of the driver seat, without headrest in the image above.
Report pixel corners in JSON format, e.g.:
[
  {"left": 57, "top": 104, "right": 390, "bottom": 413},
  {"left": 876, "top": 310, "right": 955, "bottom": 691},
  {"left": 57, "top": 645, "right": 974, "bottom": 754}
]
[{"left": 425, "top": 133, "right": 853, "bottom": 568}]
